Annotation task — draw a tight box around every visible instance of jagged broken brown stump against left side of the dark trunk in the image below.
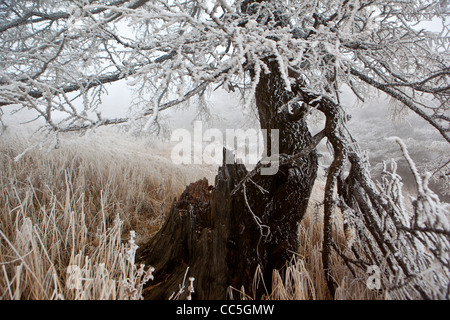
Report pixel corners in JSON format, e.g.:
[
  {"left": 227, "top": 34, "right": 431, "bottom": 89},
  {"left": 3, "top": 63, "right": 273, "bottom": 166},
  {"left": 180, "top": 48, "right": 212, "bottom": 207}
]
[{"left": 137, "top": 153, "right": 252, "bottom": 299}]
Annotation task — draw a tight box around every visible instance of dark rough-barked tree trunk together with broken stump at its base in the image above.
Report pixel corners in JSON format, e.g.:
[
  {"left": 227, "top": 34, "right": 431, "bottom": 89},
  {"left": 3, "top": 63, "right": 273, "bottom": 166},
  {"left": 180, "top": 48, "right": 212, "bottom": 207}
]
[{"left": 137, "top": 59, "right": 317, "bottom": 299}]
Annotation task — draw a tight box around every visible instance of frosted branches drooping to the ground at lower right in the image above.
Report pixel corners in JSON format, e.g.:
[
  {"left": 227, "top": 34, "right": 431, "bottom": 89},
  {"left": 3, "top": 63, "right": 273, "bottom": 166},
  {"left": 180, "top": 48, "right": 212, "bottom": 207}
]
[{"left": 342, "top": 137, "right": 450, "bottom": 299}]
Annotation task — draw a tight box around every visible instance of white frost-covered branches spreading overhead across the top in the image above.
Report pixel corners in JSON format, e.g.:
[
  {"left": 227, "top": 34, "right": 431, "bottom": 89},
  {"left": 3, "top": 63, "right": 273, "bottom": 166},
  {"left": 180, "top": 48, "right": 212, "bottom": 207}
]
[{"left": 0, "top": 0, "right": 450, "bottom": 143}]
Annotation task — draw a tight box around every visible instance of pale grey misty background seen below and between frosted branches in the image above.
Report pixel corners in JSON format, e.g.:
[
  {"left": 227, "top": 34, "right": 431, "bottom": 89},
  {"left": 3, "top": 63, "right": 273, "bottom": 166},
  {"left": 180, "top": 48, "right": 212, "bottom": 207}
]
[{"left": 1, "top": 80, "right": 450, "bottom": 202}]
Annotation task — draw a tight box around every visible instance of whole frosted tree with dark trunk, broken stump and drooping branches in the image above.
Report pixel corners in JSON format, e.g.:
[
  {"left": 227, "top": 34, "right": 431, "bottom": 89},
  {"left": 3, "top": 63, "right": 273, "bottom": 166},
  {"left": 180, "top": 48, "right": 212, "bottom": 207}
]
[{"left": 0, "top": 0, "right": 450, "bottom": 298}]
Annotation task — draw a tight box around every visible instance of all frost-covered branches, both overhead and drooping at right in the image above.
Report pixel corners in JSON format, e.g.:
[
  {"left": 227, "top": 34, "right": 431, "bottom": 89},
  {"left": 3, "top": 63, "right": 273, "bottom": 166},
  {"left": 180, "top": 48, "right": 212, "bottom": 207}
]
[{"left": 0, "top": 0, "right": 450, "bottom": 299}]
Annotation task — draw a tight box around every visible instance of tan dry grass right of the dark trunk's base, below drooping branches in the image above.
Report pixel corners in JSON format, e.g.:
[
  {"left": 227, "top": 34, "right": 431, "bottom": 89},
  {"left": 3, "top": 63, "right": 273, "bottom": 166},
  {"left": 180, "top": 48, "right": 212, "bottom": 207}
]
[{"left": 268, "top": 181, "right": 383, "bottom": 300}]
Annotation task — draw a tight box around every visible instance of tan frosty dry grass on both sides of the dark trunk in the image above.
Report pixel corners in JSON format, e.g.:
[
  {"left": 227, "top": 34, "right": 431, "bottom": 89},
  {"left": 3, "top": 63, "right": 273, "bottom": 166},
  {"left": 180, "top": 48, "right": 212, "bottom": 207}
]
[{"left": 0, "top": 132, "right": 378, "bottom": 300}]
